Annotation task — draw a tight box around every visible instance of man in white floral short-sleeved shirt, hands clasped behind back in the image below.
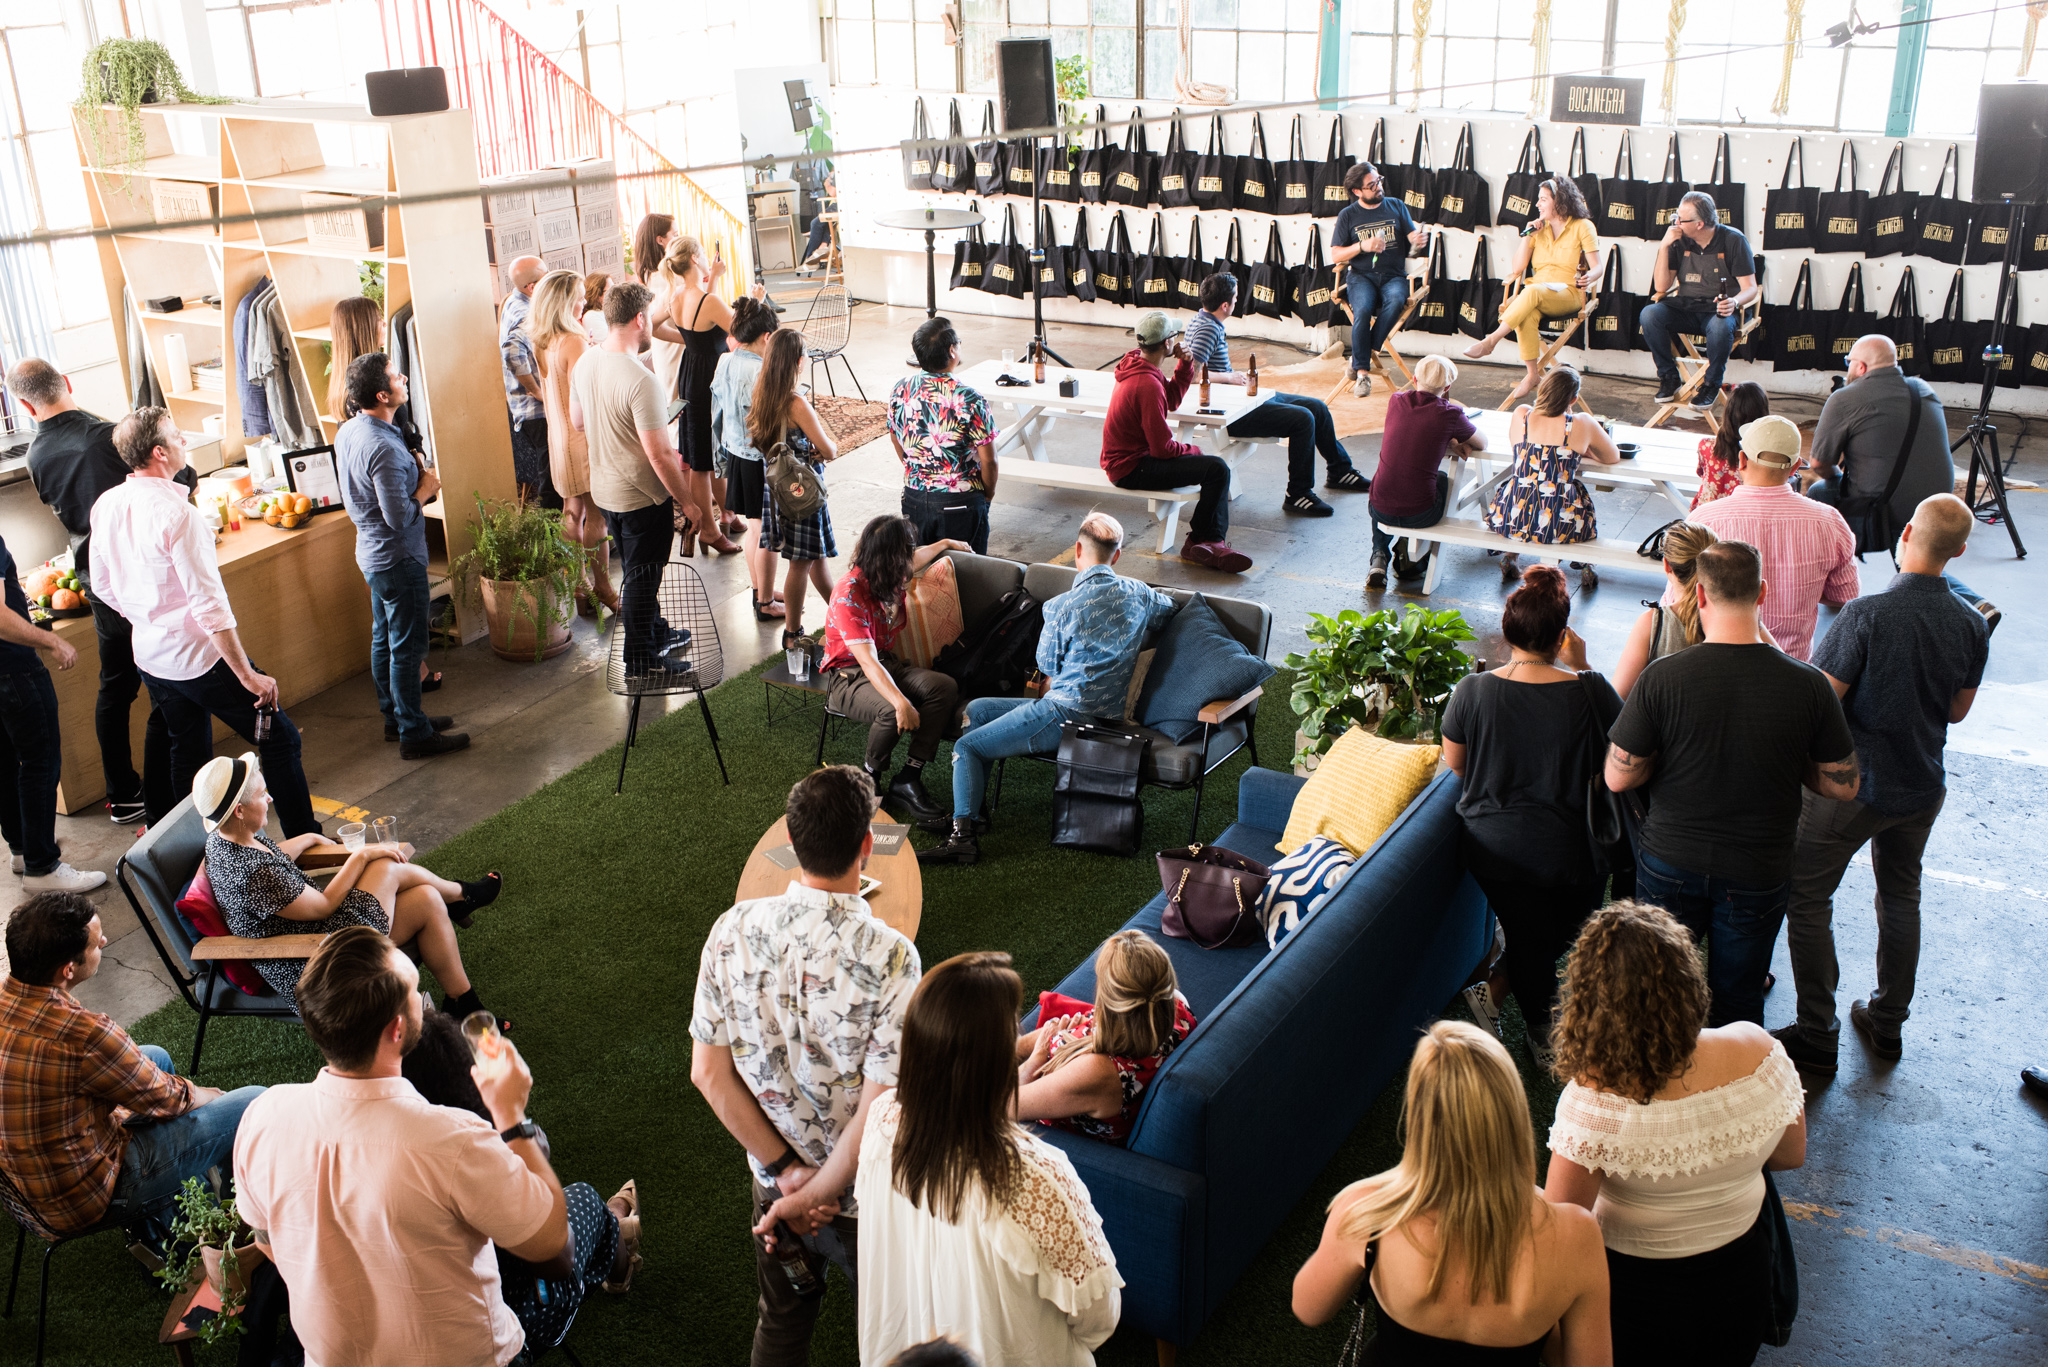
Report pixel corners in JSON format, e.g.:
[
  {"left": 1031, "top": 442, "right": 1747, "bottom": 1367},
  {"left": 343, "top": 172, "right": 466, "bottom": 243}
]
[{"left": 690, "top": 764, "right": 924, "bottom": 1367}]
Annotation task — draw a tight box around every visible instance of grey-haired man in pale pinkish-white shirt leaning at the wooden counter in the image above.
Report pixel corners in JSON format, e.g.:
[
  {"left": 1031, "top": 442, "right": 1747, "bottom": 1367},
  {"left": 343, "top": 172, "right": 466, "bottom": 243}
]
[{"left": 92, "top": 408, "right": 319, "bottom": 838}]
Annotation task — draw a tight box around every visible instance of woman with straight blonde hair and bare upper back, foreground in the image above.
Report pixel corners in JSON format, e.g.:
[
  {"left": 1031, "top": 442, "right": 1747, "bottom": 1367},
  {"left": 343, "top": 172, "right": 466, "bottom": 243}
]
[{"left": 1294, "top": 1021, "right": 1610, "bottom": 1367}]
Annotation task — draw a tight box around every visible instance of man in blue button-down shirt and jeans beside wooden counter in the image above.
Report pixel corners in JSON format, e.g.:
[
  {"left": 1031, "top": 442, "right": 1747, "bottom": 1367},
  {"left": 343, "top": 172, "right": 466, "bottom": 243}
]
[{"left": 334, "top": 350, "right": 469, "bottom": 760}]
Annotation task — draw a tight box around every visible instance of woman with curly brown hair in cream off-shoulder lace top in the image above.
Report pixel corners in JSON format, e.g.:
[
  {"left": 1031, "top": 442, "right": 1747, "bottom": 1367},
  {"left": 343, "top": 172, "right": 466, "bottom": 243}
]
[{"left": 1544, "top": 902, "right": 1806, "bottom": 1367}]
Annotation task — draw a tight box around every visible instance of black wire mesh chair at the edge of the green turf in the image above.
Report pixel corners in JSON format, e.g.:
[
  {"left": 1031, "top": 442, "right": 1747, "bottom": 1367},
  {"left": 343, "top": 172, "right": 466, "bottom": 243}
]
[{"left": 604, "top": 560, "right": 733, "bottom": 795}]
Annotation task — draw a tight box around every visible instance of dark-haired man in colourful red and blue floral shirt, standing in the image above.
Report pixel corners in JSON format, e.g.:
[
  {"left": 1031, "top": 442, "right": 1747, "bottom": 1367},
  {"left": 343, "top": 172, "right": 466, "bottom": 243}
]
[{"left": 889, "top": 318, "right": 995, "bottom": 555}]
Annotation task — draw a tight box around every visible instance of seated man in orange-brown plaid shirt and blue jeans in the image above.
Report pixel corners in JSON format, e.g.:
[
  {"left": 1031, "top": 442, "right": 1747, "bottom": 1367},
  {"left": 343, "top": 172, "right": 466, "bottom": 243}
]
[{"left": 0, "top": 892, "right": 262, "bottom": 1234}]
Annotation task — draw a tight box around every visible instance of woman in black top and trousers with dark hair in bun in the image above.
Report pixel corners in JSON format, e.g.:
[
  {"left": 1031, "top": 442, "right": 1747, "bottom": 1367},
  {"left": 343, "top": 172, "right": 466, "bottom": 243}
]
[{"left": 1444, "top": 566, "right": 1622, "bottom": 1064}]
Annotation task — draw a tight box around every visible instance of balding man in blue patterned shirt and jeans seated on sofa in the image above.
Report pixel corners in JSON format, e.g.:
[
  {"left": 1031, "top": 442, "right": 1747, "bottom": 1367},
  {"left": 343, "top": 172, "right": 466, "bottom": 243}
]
[{"left": 918, "top": 512, "right": 1176, "bottom": 865}]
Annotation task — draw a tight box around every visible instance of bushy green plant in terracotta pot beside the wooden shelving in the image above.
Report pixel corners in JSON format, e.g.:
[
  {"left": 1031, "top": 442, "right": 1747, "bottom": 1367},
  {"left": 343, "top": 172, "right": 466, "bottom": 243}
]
[{"left": 449, "top": 494, "right": 590, "bottom": 660}]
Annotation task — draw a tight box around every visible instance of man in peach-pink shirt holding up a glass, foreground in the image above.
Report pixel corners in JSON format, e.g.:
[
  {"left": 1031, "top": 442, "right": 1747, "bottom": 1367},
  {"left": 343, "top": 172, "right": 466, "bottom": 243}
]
[{"left": 236, "top": 926, "right": 596, "bottom": 1367}]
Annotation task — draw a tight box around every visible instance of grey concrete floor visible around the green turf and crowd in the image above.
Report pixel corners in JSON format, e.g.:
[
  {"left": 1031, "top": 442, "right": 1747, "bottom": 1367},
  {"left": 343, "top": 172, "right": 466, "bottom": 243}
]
[{"left": 0, "top": 305, "right": 2048, "bottom": 1365}]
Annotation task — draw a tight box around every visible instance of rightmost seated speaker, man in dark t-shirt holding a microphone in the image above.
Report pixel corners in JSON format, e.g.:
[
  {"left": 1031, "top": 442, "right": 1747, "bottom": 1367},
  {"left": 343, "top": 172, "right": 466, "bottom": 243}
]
[{"left": 1640, "top": 191, "right": 1757, "bottom": 412}]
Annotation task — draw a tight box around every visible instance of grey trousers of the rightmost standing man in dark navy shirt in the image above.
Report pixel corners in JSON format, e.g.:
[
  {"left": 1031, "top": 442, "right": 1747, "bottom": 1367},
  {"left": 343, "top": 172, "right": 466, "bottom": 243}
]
[{"left": 1786, "top": 793, "right": 1946, "bottom": 1047}]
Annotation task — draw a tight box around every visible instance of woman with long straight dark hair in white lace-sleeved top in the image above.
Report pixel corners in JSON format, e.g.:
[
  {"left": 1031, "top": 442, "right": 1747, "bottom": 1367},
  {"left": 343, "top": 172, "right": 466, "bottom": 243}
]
[{"left": 854, "top": 953, "right": 1124, "bottom": 1367}]
